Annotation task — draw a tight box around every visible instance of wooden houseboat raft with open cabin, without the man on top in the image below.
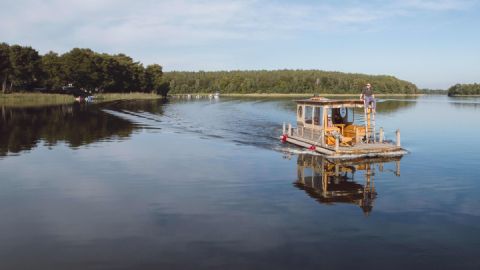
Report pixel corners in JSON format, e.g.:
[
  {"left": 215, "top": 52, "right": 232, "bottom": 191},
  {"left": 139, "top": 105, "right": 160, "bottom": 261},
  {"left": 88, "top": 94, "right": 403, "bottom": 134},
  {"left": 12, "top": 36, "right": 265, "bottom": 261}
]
[{"left": 280, "top": 97, "right": 407, "bottom": 159}]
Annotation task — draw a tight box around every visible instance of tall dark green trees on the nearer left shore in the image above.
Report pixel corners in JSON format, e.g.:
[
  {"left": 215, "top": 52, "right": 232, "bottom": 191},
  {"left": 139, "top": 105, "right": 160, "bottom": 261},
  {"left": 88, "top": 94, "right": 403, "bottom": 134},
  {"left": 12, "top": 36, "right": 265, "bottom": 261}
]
[{"left": 0, "top": 43, "right": 169, "bottom": 95}]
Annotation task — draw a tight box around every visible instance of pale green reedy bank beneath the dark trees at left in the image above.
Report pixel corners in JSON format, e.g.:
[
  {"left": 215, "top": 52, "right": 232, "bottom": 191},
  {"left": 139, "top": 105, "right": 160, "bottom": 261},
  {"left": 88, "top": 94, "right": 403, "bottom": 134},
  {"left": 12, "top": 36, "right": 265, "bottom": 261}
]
[{"left": 0, "top": 93, "right": 161, "bottom": 107}]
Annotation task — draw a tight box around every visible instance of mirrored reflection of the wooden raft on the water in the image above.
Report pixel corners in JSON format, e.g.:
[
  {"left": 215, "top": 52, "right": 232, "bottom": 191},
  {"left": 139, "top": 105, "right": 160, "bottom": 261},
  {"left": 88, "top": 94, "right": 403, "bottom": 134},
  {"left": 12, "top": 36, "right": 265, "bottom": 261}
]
[{"left": 294, "top": 154, "right": 401, "bottom": 215}]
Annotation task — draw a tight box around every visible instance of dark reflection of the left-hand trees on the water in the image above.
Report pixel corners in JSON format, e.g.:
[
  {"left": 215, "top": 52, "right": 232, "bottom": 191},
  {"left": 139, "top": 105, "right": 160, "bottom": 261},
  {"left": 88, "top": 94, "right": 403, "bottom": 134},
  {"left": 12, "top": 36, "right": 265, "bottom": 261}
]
[{"left": 0, "top": 100, "right": 165, "bottom": 157}]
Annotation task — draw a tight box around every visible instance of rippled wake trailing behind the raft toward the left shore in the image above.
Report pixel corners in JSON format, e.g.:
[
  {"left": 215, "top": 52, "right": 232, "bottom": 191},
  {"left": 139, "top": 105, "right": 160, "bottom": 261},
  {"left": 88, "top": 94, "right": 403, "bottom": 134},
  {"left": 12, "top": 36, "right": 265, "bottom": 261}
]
[{"left": 103, "top": 100, "right": 296, "bottom": 154}]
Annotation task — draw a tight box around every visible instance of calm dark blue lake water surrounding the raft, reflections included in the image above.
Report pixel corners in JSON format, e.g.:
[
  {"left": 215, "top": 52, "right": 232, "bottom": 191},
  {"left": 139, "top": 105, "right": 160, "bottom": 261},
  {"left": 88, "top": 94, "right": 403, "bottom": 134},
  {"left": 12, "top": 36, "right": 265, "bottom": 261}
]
[{"left": 0, "top": 96, "right": 480, "bottom": 269}]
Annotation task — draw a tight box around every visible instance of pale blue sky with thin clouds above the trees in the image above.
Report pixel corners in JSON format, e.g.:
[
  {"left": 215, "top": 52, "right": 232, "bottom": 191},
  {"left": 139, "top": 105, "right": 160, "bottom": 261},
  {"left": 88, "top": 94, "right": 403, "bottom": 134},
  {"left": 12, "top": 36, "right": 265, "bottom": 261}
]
[{"left": 0, "top": 0, "right": 480, "bottom": 89}]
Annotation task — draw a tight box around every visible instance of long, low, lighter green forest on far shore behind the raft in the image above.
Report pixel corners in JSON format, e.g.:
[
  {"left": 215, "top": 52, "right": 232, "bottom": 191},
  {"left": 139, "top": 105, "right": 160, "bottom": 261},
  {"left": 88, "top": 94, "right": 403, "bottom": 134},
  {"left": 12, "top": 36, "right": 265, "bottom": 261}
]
[{"left": 164, "top": 70, "right": 418, "bottom": 94}]
